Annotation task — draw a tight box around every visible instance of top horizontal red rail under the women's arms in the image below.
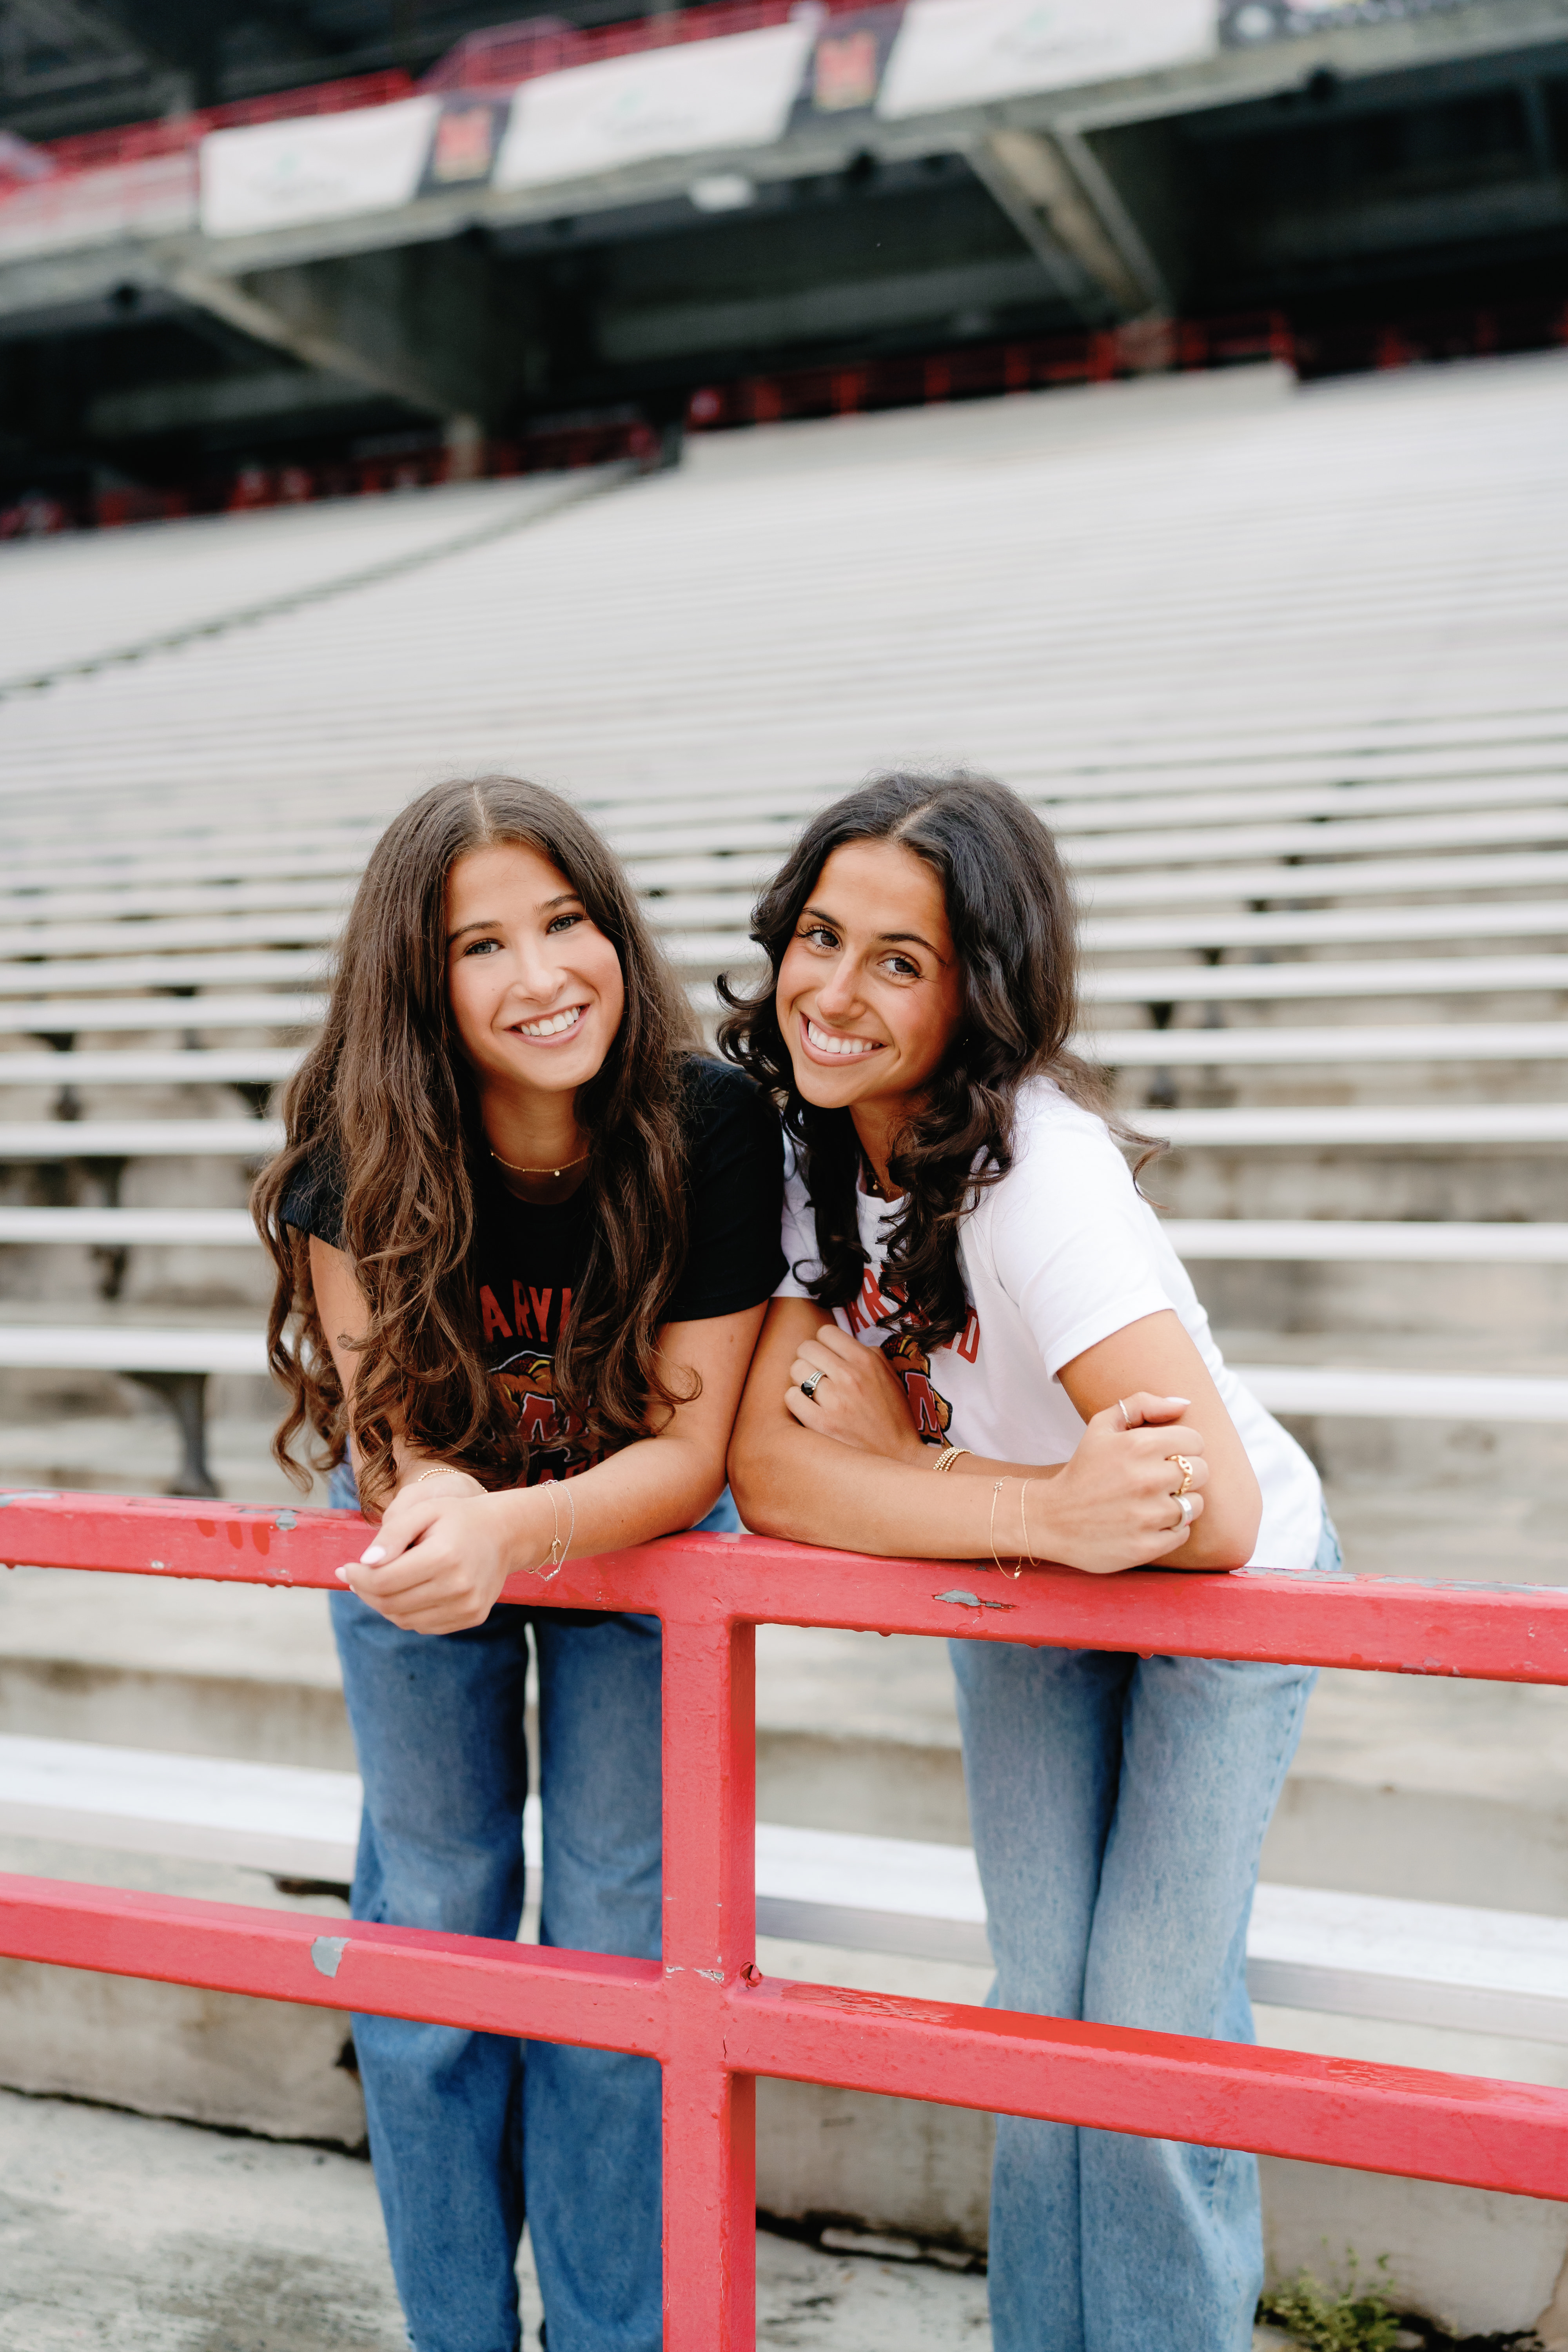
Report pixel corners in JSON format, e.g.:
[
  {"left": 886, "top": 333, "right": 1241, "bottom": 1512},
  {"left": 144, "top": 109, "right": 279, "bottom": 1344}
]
[{"left": 0, "top": 1489, "right": 1568, "bottom": 1684}]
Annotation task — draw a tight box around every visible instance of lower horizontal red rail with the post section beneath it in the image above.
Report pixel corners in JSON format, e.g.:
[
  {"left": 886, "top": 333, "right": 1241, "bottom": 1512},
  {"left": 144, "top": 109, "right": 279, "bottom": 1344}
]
[{"left": 0, "top": 1877, "right": 1568, "bottom": 2201}]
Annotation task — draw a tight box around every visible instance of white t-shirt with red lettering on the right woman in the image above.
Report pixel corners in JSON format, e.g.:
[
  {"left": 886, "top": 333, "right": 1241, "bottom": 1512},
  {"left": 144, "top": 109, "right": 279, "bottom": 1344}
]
[{"left": 773, "top": 1077, "right": 1323, "bottom": 1569}]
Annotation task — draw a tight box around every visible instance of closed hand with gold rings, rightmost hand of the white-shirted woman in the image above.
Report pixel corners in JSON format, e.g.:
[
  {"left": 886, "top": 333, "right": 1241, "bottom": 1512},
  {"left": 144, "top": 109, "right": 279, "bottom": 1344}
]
[{"left": 1051, "top": 1392, "right": 1208, "bottom": 1576}]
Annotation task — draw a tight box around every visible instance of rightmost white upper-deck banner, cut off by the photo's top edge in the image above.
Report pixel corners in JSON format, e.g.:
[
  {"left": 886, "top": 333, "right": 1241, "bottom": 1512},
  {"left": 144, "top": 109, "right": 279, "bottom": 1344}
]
[{"left": 877, "top": 0, "right": 1220, "bottom": 115}]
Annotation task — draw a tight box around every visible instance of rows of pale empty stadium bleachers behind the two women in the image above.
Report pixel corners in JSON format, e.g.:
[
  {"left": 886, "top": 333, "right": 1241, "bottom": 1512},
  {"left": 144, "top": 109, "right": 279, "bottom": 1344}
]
[{"left": 0, "top": 358, "right": 1568, "bottom": 2314}]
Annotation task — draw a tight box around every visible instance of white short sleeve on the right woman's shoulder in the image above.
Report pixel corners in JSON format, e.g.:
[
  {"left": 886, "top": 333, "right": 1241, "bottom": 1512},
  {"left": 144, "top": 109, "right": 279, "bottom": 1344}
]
[{"left": 990, "top": 1110, "right": 1176, "bottom": 1378}]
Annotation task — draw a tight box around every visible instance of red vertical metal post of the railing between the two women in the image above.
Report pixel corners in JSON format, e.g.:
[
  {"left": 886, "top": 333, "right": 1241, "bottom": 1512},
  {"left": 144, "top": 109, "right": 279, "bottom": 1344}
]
[{"left": 663, "top": 1595, "right": 757, "bottom": 2352}]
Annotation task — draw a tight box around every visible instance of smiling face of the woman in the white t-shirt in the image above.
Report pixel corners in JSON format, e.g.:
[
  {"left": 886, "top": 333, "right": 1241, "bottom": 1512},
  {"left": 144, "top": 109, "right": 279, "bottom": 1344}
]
[{"left": 776, "top": 842, "right": 964, "bottom": 1171}]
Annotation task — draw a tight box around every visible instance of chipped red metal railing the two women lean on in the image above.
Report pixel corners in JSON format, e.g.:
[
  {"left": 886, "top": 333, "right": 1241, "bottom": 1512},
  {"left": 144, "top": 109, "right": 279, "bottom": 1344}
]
[{"left": 0, "top": 1491, "right": 1568, "bottom": 2352}]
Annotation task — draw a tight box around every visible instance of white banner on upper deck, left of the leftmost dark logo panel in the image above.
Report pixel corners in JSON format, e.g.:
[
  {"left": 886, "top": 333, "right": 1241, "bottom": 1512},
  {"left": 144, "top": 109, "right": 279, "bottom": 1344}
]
[{"left": 202, "top": 99, "right": 442, "bottom": 238}]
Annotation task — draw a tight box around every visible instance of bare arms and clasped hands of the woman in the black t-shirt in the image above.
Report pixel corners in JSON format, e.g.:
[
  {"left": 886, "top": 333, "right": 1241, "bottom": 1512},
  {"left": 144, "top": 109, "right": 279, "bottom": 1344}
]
[{"left": 310, "top": 1242, "right": 764, "bottom": 1632}]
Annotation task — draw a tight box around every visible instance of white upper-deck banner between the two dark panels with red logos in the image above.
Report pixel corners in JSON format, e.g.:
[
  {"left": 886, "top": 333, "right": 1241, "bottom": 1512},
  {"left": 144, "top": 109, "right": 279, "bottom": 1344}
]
[{"left": 494, "top": 21, "right": 816, "bottom": 188}]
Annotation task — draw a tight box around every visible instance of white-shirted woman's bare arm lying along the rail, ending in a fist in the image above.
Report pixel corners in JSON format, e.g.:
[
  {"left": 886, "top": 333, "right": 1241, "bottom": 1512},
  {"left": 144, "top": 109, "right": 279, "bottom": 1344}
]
[{"left": 729, "top": 1298, "right": 1222, "bottom": 1573}]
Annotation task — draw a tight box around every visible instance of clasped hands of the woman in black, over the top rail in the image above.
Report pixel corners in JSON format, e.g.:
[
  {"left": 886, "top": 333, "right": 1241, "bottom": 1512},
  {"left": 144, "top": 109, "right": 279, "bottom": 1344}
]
[{"left": 339, "top": 1470, "right": 550, "bottom": 1632}]
